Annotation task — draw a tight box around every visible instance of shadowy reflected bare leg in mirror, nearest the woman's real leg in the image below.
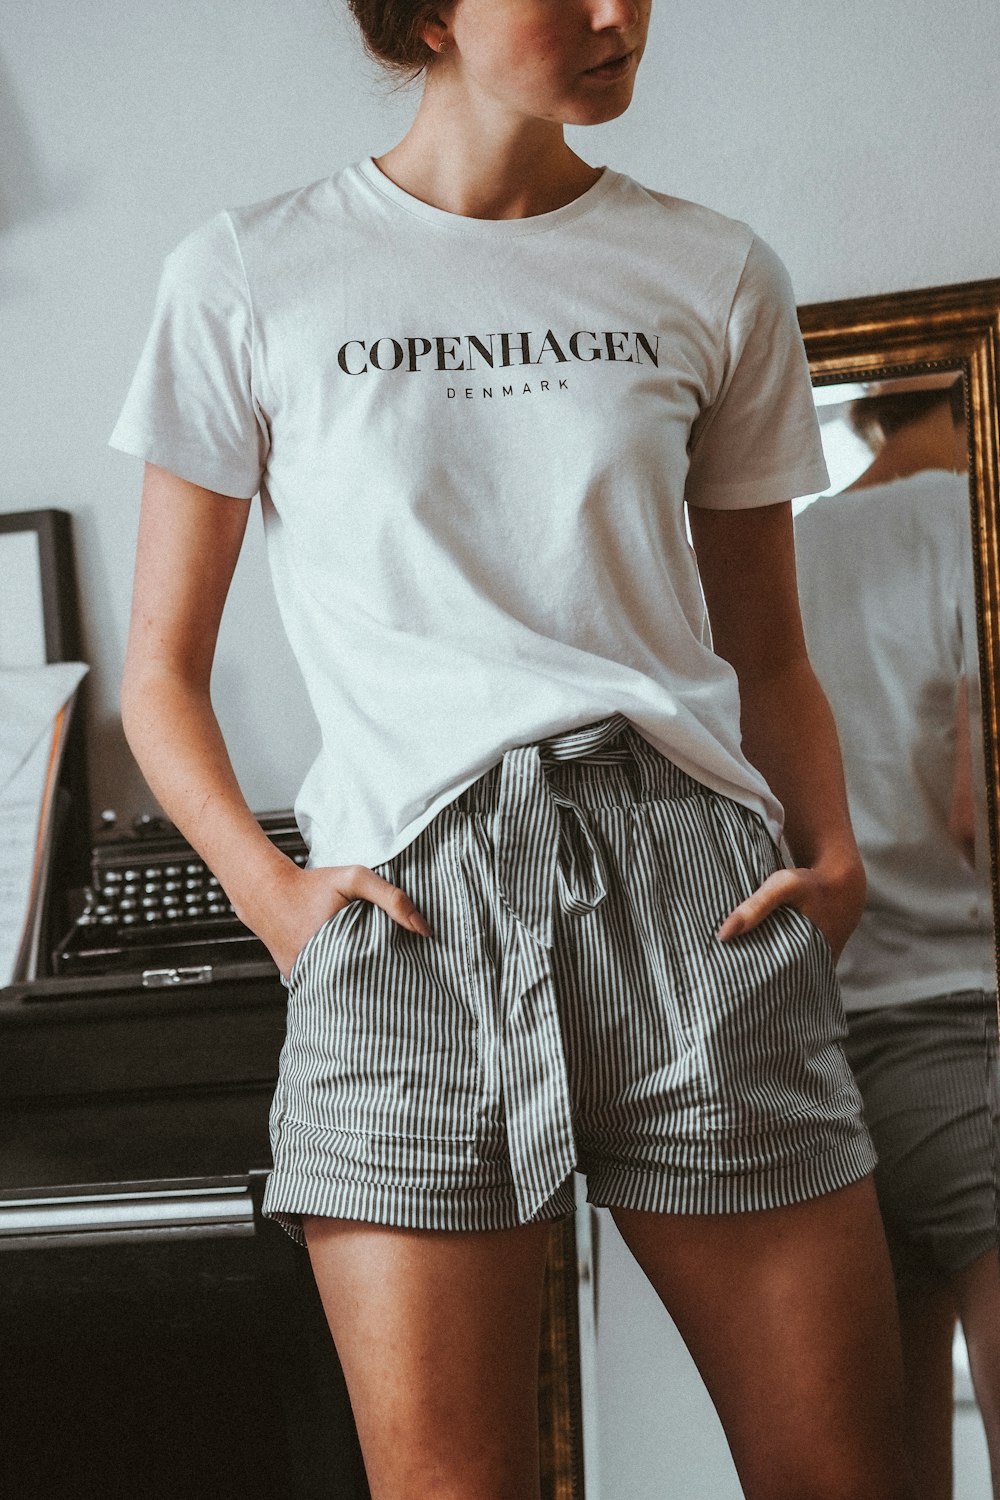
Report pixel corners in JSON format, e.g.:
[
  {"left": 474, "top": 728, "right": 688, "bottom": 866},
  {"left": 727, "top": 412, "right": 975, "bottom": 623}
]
[{"left": 900, "top": 1284, "right": 957, "bottom": 1500}]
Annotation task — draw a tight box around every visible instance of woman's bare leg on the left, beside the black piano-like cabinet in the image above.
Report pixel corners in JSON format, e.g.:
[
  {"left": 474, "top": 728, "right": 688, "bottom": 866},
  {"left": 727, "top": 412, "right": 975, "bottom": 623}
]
[{"left": 303, "top": 1218, "right": 549, "bottom": 1500}]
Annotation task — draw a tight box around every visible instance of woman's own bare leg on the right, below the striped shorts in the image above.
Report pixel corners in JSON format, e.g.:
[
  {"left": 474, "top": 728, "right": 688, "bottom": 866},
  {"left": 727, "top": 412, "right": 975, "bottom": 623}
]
[{"left": 615, "top": 1179, "right": 915, "bottom": 1500}]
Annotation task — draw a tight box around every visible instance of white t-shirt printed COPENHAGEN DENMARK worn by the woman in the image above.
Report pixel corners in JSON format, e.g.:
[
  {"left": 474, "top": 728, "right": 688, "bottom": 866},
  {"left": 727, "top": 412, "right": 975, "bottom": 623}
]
[{"left": 111, "top": 162, "right": 828, "bottom": 866}]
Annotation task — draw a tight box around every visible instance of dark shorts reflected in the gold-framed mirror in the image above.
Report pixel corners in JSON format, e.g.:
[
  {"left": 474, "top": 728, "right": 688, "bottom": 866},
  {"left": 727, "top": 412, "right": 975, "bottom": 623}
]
[{"left": 844, "top": 990, "right": 1000, "bottom": 1292}]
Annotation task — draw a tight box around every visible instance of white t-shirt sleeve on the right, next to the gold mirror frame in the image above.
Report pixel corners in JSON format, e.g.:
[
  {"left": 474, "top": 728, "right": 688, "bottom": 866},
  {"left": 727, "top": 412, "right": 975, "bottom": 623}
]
[{"left": 685, "top": 239, "right": 829, "bottom": 510}]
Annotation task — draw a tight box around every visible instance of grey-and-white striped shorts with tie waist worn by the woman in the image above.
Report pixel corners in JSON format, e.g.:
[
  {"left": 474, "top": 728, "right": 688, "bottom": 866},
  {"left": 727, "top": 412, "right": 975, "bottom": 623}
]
[{"left": 264, "top": 716, "right": 874, "bottom": 1241}]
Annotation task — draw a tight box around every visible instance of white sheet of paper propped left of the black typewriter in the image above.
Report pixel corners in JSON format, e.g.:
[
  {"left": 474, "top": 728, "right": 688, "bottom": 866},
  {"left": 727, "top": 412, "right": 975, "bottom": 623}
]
[{"left": 0, "top": 662, "right": 87, "bottom": 986}]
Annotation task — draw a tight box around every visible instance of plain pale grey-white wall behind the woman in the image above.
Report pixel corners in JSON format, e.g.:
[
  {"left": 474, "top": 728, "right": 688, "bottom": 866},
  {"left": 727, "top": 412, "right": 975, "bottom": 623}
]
[{"left": 0, "top": 0, "right": 1000, "bottom": 1500}]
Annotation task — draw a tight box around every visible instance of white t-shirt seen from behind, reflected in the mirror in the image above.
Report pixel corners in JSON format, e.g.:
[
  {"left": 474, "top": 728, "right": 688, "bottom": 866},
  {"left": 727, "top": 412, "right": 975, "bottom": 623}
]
[{"left": 795, "top": 471, "right": 996, "bottom": 1010}]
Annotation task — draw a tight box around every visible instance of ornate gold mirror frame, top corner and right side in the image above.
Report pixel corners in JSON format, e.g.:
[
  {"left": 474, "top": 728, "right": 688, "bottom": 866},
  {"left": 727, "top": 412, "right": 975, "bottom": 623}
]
[{"left": 799, "top": 281, "right": 1000, "bottom": 996}]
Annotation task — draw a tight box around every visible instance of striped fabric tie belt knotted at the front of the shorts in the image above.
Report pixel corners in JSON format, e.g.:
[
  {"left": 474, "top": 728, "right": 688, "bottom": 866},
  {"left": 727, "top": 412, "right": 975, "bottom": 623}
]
[{"left": 495, "top": 714, "right": 633, "bottom": 1221}]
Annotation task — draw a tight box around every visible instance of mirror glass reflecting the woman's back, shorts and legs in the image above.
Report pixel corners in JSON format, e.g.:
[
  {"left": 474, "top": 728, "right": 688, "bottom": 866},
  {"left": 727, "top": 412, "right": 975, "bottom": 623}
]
[{"left": 795, "top": 369, "right": 1000, "bottom": 1500}]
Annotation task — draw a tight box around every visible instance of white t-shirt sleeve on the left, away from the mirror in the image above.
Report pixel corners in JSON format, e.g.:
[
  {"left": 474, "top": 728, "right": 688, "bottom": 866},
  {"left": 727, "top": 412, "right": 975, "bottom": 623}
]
[{"left": 111, "top": 215, "right": 268, "bottom": 500}]
